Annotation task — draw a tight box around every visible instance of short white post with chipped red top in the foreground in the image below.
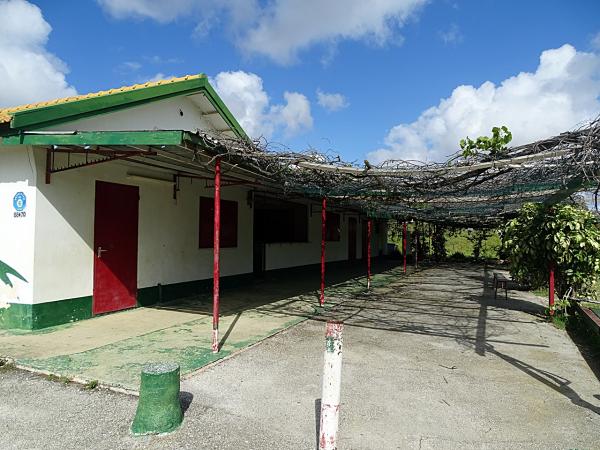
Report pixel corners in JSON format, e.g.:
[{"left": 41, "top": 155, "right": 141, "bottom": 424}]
[{"left": 319, "top": 321, "right": 344, "bottom": 450}]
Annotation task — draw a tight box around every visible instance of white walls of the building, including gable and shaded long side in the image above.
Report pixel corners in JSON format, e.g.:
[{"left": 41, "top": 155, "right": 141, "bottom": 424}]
[{"left": 0, "top": 90, "right": 386, "bottom": 307}]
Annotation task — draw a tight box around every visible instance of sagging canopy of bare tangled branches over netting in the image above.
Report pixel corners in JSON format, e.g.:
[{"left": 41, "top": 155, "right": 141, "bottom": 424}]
[{"left": 176, "top": 118, "right": 600, "bottom": 225}]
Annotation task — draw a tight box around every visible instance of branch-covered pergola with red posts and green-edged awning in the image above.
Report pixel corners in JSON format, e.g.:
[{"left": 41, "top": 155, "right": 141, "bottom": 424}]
[{"left": 2, "top": 121, "right": 600, "bottom": 352}]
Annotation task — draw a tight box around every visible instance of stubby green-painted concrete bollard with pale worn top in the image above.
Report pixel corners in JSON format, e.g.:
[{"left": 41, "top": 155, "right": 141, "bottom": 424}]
[{"left": 131, "top": 363, "right": 183, "bottom": 435}]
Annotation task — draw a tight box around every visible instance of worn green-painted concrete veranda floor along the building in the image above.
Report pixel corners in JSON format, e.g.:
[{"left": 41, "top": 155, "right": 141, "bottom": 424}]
[{"left": 0, "top": 261, "right": 390, "bottom": 391}]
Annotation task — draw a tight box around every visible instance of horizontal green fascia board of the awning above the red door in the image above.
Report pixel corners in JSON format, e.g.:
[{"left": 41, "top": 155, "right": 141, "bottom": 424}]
[{"left": 0, "top": 131, "right": 184, "bottom": 146}]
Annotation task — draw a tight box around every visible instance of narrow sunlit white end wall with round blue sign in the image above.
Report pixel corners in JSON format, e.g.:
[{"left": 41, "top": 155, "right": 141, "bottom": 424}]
[{"left": 0, "top": 147, "right": 36, "bottom": 308}]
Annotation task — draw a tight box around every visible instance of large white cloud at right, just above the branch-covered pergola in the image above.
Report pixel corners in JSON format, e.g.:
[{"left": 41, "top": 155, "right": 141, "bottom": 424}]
[{"left": 368, "top": 44, "right": 600, "bottom": 162}]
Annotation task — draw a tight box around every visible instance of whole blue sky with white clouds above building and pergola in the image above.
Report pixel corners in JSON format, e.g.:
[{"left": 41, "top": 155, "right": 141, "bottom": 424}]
[{"left": 0, "top": 0, "right": 600, "bottom": 162}]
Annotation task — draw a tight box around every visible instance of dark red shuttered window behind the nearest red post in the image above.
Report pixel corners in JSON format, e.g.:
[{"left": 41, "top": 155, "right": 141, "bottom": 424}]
[{"left": 199, "top": 197, "right": 237, "bottom": 248}]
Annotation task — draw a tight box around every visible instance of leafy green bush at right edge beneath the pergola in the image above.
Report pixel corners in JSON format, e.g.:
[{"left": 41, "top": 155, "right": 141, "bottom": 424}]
[{"left": 502, "top": 203, "right": 600, "bottom": 298}]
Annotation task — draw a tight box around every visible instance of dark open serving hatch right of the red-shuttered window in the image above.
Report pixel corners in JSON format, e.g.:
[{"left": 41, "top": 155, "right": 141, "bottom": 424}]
[{"left": 254, "top": 197, "right": 308, "bottom": 243}]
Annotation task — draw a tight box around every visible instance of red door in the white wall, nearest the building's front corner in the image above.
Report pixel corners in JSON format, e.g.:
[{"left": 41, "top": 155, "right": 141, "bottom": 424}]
[{"left": 93, "top": 181, "right": 139, "bottom": 314}]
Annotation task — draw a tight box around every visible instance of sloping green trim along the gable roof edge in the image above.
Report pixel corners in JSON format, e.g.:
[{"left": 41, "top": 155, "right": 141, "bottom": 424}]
[{"left": 5, "top": 75, "right": 249, "bottom": 139}]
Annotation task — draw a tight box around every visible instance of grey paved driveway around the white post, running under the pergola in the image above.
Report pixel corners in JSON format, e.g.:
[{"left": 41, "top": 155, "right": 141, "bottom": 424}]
[{"left": 0, "top": 266, "right": 600, "bottom": 449}]
